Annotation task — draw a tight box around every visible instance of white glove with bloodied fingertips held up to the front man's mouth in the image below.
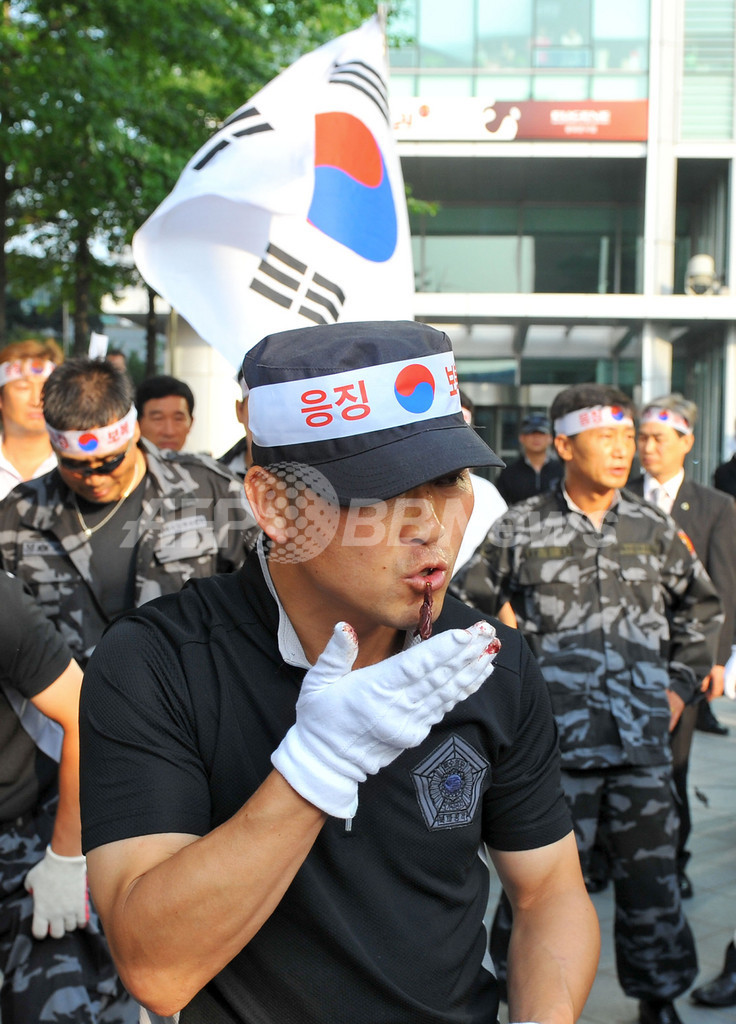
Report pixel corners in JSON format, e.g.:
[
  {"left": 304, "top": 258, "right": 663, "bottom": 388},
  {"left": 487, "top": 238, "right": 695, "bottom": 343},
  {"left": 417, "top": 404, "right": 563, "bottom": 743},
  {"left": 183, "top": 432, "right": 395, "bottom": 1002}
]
[{"left": 271, "top": 622, "right": 501, "bottom": 818}]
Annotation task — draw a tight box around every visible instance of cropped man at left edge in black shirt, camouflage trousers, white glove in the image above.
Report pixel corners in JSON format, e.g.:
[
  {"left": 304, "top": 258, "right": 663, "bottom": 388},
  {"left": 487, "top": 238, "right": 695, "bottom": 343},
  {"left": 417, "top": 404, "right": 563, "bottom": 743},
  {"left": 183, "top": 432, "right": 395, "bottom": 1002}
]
[{"left": 0, "top": 572, "right": 138, "bottom": 1024}]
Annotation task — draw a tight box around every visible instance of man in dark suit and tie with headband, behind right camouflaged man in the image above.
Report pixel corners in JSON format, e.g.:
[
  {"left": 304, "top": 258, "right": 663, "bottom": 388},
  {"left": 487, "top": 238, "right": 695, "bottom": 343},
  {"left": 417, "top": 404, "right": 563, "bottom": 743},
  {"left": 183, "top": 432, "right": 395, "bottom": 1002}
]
[{"left": 629, "top": 394, "right": 736, "bottom": 897}]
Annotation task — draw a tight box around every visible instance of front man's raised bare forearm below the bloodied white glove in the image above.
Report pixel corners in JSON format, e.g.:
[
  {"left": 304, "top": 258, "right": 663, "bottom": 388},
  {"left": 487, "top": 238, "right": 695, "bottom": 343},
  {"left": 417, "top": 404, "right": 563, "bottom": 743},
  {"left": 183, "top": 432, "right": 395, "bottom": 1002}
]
[{"left": 87, "top": 771, "right": 327, "bottom": 1016}]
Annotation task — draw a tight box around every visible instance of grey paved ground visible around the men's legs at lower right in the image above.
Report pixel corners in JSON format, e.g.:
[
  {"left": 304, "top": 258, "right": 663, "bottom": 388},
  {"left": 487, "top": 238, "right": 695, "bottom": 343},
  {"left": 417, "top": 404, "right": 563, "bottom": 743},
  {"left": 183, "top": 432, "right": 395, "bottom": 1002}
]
[{"left": 491, "top": 697, "right": 736, "bottom": 1024}]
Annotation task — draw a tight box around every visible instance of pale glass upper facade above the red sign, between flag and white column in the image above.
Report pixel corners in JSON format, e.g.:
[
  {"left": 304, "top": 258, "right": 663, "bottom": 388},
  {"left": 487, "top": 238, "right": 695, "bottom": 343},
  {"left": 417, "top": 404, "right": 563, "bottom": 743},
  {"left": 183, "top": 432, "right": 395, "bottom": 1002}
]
[{"left": 391, "top": 0, "right": 649, "bottom": 100}]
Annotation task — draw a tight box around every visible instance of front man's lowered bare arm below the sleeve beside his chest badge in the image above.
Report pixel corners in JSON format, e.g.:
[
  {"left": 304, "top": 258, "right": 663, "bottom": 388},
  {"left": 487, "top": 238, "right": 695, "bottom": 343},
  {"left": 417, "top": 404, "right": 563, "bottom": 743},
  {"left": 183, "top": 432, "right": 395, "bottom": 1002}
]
[{"left": 490, "top": 833, "right": 600, "bottom": 1024}]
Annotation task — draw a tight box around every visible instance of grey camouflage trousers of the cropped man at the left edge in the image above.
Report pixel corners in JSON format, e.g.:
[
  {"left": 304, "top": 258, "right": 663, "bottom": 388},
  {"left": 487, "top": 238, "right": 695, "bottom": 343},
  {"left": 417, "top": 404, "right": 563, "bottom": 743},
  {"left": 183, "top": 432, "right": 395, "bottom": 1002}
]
[{"left": 0, "top": 799, "right": 138, "bottom": 1024}]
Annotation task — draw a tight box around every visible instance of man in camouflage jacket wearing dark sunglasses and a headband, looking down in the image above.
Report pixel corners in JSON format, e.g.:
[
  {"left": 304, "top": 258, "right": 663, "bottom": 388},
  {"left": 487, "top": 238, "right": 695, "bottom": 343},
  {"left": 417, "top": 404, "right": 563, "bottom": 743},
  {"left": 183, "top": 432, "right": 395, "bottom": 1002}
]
[{"left": 0, "top": 359, "right": 255, "bottom": 667}]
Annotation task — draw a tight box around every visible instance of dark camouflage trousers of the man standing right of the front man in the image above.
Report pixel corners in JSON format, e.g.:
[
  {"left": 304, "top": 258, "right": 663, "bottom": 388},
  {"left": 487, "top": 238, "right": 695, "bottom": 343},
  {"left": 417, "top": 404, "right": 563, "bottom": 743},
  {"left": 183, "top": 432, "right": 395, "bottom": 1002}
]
[{"left": 490, "top": 765, "right": 697, "bottom": 999}]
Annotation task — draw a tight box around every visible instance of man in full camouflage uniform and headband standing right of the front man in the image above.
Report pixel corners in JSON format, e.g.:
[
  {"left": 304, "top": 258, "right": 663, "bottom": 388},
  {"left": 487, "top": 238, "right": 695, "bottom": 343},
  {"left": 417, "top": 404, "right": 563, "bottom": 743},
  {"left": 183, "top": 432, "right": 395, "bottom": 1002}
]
[{"left": 464, "top": 384, "right": 723, "bottom": 1024}]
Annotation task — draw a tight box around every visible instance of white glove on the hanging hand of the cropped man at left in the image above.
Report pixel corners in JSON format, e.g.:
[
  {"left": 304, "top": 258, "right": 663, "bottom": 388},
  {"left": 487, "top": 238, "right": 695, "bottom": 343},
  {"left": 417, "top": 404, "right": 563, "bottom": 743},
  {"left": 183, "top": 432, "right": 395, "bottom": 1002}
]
[{"left": 26, "top": 846, "right": 89, "bottom": 939}]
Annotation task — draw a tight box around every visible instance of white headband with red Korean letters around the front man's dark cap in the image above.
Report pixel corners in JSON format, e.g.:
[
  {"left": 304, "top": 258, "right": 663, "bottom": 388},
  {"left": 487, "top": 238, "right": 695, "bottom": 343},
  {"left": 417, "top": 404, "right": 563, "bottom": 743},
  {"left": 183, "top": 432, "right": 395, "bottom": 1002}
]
[{"left": 249, "top": 352, "right": 461, "bottom": 447}]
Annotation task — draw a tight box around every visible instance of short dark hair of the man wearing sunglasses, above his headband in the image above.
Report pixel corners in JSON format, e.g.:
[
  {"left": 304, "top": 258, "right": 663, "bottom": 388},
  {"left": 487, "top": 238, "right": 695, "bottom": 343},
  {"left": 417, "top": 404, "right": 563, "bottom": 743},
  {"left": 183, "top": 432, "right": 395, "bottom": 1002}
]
[{"left": 43, "top": 358, "right": 133, "bottom": 430}]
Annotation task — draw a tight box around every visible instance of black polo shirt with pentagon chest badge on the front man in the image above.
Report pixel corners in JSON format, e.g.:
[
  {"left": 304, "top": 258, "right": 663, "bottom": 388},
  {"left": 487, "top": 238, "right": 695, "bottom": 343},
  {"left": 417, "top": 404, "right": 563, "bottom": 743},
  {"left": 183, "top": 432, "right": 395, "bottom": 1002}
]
[{"left": 81, "top": 554, "right": 571, "bottom": 1024}]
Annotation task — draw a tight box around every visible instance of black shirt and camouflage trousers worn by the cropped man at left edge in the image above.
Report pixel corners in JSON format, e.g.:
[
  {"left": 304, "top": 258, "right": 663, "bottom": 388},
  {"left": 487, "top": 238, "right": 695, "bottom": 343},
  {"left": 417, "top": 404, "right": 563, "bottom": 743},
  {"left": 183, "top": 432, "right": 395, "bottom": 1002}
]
[{"left": 0, "top": 572, "right": 137, "bottom": 1024}]
